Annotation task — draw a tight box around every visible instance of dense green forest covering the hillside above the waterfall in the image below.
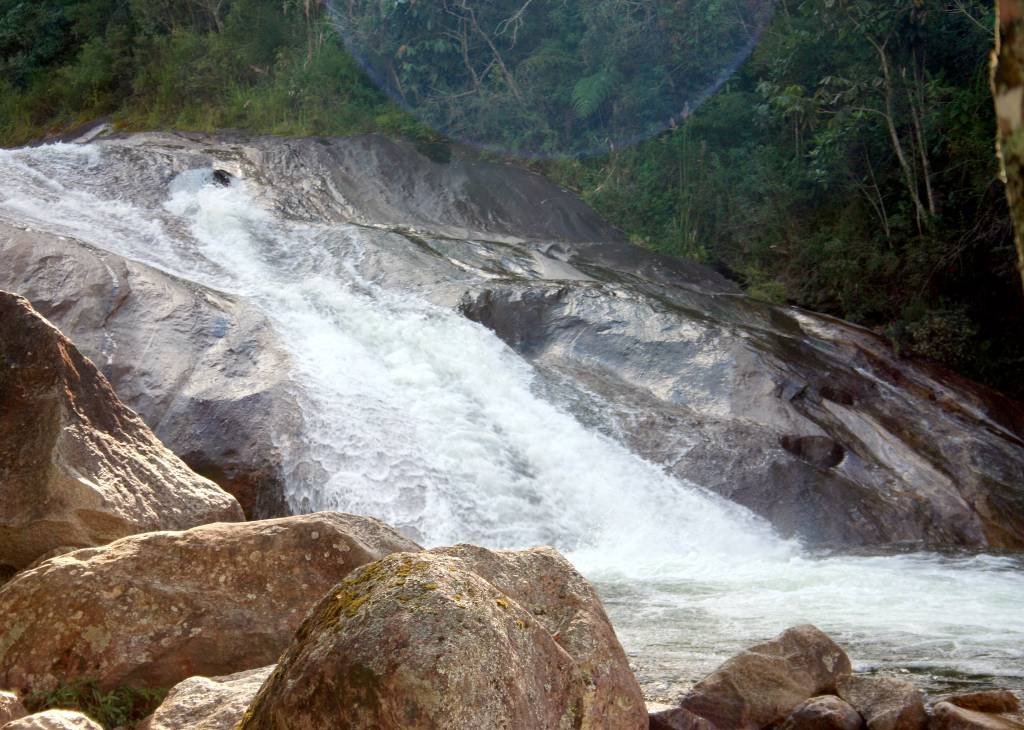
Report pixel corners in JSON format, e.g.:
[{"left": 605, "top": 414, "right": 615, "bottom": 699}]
[{"left": 0, "top": 0, "right": 1024, "bottom": 396}]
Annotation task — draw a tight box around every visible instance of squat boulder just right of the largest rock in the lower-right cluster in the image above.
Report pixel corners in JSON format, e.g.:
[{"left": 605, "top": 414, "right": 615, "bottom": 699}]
[{"left": 839, "top": 675, "right": 928, "bottom": 730}]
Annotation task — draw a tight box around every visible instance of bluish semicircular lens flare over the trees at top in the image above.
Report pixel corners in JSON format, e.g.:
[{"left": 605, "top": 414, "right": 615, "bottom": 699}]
[{"left": 326, "top": 0, "right": 774, "bottom": 158}]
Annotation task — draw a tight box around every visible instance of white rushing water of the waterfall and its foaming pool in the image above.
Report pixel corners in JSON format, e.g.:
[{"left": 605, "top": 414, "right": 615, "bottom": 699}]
[{"left": 0, "top": 145, "right": 1024, "bottom": 692}]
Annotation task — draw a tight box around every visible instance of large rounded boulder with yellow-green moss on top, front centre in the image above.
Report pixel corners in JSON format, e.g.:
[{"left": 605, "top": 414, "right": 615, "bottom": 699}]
[{"left": 239, "top": 550, "right": 647, "bottom": 730}]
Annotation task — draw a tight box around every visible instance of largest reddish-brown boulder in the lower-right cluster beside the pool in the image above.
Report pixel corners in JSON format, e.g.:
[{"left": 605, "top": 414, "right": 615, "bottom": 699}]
[{"left": 680, "top": 626, "right": 851, "bottom": 730}]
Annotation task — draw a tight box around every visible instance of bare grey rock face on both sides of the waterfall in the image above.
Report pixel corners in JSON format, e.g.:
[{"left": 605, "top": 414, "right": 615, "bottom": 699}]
[{"left": 0, "top": 134, "right": 1024, "bottom": 548}]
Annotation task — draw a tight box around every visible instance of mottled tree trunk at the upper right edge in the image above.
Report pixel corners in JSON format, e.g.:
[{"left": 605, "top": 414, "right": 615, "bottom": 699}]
[{"left": 992, "top": 0, "right": 1024, "bottom": 290}]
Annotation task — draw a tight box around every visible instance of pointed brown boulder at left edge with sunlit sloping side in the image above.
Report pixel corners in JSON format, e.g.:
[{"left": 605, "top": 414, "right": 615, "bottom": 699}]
[{"left": 0, "top": 292, "right": 244, "bottom": 568}]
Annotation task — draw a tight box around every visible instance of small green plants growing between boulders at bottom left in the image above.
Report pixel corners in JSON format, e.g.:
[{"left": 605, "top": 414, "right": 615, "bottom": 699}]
[{"left": 25, "top": 681, "right": 167, "bottom": 729}]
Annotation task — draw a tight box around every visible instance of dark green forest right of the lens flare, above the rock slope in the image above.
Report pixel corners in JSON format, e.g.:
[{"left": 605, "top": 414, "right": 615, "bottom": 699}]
[{"left": 546, "top": 0, "right": 1024, "bottom": 396}]
